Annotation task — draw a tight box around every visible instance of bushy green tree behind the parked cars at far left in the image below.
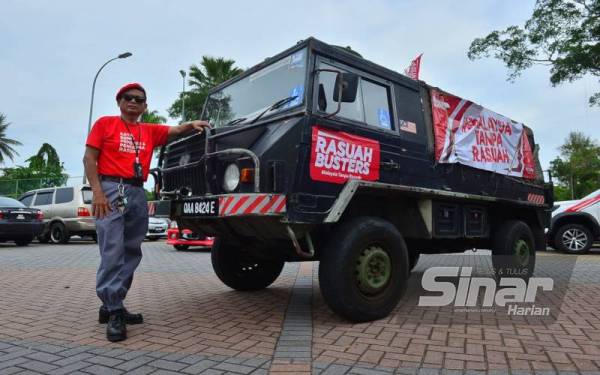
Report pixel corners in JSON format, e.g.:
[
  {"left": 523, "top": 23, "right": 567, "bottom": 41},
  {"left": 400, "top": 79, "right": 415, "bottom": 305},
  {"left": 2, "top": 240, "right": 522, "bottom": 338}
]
[{"left": 0, "top": 143, "right": 69, "bottom": 196}]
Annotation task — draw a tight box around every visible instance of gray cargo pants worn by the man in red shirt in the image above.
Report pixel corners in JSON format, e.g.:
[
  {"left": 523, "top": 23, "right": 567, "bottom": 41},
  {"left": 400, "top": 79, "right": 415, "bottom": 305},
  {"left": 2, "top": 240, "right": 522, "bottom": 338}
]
[{"left": 96, "top": 181, "right": 148, "bottom": 311}]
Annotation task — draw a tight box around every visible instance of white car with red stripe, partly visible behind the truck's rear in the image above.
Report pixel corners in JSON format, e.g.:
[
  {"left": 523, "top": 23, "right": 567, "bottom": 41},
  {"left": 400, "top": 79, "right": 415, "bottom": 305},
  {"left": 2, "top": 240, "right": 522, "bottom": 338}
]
[{"left": 547, "top": 189, "right": 600, "bottom": 254}]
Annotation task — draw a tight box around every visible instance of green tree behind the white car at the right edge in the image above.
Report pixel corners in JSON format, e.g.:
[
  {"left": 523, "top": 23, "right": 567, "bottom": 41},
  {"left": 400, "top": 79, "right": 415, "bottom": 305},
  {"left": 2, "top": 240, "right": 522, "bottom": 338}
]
[{"left": 550, "top": 132, "right": 600, "bottom": 200}]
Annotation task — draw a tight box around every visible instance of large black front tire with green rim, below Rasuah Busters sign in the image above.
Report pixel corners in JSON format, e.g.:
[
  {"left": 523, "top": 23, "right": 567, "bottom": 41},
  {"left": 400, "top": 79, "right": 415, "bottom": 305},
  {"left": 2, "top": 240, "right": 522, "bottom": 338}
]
[{"left": 319, "top": 217, "right": 409, "bottom": 322}]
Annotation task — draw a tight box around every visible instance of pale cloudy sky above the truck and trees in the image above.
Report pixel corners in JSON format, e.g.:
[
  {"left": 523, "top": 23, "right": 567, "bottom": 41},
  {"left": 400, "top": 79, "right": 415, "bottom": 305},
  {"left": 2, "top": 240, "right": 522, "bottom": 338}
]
[{"left": 0, "top": 0, "right": 600, "bottom": 184}]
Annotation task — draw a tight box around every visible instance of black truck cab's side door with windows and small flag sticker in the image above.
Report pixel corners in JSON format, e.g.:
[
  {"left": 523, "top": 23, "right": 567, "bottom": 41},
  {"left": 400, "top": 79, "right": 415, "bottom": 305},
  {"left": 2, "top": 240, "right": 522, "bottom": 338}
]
[{"left": 314, "top": 58, "right": 431, "bottom": 184}]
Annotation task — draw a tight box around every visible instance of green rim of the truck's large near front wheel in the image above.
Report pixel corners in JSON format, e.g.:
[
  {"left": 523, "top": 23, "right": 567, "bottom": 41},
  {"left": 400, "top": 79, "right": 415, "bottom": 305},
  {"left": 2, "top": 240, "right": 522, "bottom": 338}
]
[{"left": 356, "top": 246, "right": 392, "bottom": 295}]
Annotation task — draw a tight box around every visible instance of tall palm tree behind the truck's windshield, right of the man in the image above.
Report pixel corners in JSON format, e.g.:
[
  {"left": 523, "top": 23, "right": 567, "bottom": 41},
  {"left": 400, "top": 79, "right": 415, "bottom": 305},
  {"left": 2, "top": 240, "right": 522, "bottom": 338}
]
[{"left": 168, "top": 56, "right": 244, "bottom": 121}]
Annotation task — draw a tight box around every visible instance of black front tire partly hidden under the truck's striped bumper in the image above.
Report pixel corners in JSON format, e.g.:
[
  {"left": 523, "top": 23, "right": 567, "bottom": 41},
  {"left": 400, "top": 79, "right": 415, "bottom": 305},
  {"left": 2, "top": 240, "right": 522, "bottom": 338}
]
[{"left": 210, "top": 238, "right": 284, "bottom": 291}]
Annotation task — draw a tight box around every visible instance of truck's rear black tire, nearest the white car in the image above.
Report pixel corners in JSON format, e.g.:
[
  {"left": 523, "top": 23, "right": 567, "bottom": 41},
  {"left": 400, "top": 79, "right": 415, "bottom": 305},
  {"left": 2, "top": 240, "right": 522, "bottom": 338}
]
[{"left": 492, "top": 220, "right": 535, "bottom": 279}]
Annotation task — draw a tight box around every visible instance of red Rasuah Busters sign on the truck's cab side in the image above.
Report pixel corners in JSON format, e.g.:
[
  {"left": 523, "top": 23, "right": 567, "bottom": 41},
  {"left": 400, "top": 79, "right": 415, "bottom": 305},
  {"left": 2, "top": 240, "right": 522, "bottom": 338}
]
[{"left": 310, "top": 126, "right": 379, "bottom": 184}]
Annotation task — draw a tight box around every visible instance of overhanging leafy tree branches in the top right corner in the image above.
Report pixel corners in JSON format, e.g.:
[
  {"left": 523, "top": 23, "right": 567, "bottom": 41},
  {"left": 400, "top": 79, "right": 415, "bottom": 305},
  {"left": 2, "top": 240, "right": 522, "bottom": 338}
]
[{"left": 468, "top": 0, "right": 600, "bottom": 105}]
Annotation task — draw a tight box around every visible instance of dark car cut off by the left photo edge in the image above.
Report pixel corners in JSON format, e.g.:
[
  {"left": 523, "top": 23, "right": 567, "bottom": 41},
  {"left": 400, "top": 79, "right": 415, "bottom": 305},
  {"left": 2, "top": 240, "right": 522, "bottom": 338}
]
[{"left": 0, "top": 197, "right": 44, "bottom": 246}]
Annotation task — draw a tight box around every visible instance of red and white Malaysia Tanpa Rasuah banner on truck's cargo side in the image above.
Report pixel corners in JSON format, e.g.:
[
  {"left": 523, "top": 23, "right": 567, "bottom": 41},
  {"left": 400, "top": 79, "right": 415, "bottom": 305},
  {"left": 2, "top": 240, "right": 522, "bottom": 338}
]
[{"left": 431, "top": 89, "right": 535, "bottom": 179}]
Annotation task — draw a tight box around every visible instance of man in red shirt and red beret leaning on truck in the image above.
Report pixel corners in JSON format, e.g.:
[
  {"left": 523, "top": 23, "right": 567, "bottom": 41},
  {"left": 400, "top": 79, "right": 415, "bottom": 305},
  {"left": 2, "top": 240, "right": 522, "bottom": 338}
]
[{"left": 83, "top": 83, "right": 209, "bottom": 341}]
